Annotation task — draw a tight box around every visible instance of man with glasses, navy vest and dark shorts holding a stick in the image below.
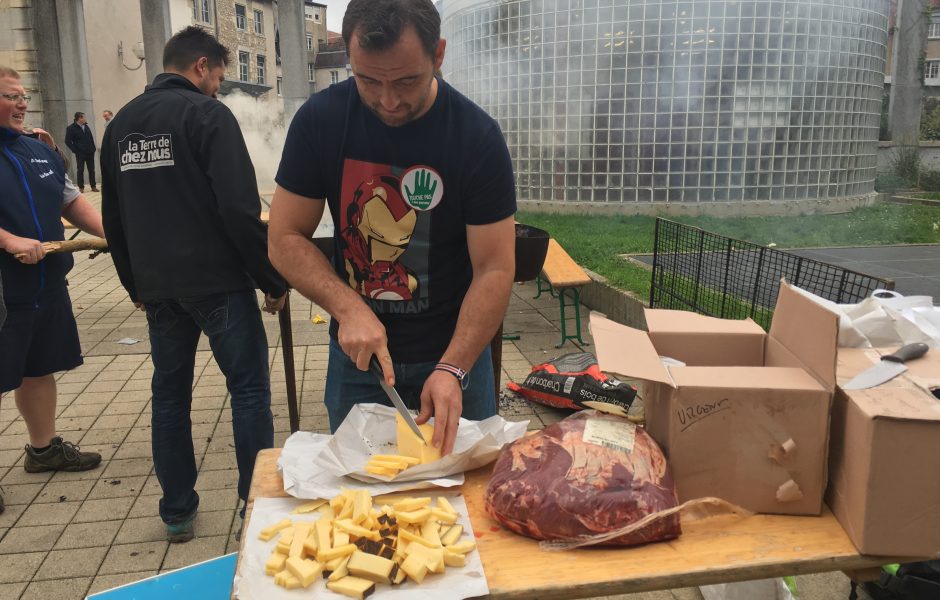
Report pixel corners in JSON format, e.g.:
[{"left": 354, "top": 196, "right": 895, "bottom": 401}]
[{"left": 0, "top": 66, "right": 104, "bottom": 516}]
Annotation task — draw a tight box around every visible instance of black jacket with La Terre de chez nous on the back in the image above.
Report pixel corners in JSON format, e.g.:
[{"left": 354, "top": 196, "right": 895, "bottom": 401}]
[{"left": 101, "top": 73, "right": 287, "bottom": 302}]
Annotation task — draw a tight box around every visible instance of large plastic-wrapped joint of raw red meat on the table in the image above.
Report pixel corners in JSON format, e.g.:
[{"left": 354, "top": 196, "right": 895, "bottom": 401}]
[{"left": 484, "top": 410, "right": 681, "bottom": 546}]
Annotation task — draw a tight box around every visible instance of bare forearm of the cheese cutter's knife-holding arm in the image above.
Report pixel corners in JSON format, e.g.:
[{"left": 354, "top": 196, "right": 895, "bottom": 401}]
[{"left": 270, "top": 234, "right": 367, "bottom": 322}]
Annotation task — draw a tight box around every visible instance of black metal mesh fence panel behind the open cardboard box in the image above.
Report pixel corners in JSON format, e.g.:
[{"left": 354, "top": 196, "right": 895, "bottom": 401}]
[{"left": 650, "top": 219, "right": 894, "bottom": 329}]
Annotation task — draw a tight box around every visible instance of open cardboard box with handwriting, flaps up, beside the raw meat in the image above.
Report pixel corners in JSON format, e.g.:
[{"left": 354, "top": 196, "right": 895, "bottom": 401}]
[{"left": 591, "top": 282, "right": 839, "bottom": 515}]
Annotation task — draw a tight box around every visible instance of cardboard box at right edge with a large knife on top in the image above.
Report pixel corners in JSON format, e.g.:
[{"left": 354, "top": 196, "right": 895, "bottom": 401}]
[{"left": 826, "top": 348, "right": 940, "bottom": 557}]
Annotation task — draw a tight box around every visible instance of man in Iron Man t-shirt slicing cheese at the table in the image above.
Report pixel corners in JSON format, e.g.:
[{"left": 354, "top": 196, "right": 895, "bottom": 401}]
[{"left": 268, "top": 0, "right": 516, "bottom": 454}]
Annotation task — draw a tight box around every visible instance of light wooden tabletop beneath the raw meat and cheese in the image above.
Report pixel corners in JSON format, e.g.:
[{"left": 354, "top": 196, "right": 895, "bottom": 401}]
[{"left": 242, "top": 449, "right": 912, "bottom": 600}]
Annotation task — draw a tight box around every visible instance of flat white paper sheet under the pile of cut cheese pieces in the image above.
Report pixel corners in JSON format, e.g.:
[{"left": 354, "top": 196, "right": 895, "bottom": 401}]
[{"left": 232, "top": 492, "right": 490, "bottom": 600}]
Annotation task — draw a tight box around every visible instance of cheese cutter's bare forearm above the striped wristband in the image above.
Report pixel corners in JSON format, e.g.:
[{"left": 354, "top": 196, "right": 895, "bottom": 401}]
[{"left": 441, "top": 270, "right": 513, "bottom": 370}]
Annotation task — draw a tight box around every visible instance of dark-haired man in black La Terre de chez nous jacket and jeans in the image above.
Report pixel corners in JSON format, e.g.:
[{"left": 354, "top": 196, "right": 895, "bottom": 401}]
[{"left": 101, "top": 27, "right": 287, "bottom": 542}]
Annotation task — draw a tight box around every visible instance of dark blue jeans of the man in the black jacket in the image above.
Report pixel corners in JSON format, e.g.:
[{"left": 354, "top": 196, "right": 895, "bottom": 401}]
[{"left": 145, "top": 290, "right": 274, "bottom": 524}]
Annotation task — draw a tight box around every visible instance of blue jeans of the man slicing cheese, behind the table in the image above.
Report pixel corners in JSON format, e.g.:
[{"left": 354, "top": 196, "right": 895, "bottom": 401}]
[{"left": 324, "top": 338, "right": 496, "bottom": 432}]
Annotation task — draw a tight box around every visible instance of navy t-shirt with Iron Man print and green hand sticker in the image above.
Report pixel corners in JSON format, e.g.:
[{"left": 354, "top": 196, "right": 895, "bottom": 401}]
[{"left": 275, "top": 79, "right": 516, "bottom": 363}]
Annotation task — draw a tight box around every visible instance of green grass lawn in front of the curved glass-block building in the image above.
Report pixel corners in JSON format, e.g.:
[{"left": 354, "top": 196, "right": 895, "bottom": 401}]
[{"left": 516, "top": 203, "right": 940, "bottom": 300}]
